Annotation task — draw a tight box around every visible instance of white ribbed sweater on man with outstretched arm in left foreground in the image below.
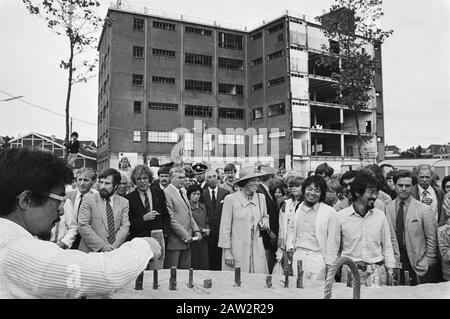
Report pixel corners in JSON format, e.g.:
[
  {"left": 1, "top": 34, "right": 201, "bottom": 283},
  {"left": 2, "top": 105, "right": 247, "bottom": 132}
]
[{"left": 0, "top": 218, "right": 153, "bottom": 298}]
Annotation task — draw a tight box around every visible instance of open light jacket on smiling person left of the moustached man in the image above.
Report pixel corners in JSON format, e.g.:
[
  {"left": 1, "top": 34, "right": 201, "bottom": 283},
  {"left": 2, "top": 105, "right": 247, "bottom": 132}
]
[{"left": 286, "top": 203, "right": 340, "bottom": 265}]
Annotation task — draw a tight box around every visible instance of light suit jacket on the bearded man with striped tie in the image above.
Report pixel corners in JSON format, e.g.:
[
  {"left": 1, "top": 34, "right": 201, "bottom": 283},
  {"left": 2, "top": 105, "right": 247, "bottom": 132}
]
[{"left": 78, "top": 193, "right": 130, "bottom": 252}]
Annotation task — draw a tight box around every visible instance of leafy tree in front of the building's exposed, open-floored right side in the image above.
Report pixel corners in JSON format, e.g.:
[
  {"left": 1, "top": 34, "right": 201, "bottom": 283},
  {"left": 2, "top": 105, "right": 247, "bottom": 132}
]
[{"left": 316, "top": 0, "right": 393, "bottom": 161}]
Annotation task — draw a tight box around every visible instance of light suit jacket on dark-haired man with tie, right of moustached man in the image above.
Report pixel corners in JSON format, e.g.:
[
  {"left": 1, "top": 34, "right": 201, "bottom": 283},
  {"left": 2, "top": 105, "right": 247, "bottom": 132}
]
[{"left": 385, "top": 198, "right": 438, "bottom": 276}]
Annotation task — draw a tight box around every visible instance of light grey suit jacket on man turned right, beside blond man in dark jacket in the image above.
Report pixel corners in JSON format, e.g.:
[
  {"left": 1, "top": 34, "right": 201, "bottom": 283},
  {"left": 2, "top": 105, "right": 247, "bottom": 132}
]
[{"left": 164, "top": 184, "right": 199, "bottom": 250}]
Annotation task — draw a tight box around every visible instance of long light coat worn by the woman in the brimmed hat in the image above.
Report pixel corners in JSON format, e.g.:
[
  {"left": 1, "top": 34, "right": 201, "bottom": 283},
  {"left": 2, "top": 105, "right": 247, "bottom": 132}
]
[{"left": 218, "top": 191, "right": 269, "bottom": 274}]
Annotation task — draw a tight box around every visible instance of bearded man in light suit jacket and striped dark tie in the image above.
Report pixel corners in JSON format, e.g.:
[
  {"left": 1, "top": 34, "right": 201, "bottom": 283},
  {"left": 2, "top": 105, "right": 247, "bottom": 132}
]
[{"left": 78, "top": 168, "right": 130, "bottom": 252}]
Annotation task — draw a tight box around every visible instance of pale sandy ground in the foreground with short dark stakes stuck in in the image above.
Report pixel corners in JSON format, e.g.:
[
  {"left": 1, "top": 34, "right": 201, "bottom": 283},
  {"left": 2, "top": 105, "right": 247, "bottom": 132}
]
[{"left": 112, "top": 269, "right": 450, "bottom": 299}]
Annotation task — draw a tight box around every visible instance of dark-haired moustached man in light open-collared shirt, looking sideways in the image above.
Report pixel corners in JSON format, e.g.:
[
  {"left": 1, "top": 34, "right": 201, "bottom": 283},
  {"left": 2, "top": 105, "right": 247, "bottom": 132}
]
[{"left": 337, "top": 172, "right": 395, "bottom": 282}]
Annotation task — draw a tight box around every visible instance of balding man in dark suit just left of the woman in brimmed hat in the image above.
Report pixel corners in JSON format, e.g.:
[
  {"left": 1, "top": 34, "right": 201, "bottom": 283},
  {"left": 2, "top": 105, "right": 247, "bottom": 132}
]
[{"left": 200, "top": 170, "right": 230, "bottom": 270}]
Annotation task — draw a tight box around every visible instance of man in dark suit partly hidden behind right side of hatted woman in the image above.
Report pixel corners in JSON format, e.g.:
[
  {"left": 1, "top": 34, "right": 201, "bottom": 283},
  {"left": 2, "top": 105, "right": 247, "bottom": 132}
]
[{"left": 257, "top": 166, "right": 280, "bottom": 273}]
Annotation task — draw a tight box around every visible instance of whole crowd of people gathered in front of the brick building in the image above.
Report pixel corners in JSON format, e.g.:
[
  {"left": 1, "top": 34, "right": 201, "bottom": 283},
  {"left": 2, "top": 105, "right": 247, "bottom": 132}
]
[{"left": 0, "top": 150, "right": 450, "bottom": 297}]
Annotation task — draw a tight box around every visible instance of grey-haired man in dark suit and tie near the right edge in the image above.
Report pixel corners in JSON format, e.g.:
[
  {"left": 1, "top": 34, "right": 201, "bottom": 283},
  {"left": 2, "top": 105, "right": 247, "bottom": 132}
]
[{"left": 412, "top": 164, "right": 445, "bottom": 226}]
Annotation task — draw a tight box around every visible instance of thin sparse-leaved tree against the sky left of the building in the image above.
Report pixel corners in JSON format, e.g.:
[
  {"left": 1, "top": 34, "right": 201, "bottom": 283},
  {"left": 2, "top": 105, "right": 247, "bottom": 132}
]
[{"left": 22, "top": 0, "right": 102, "bottom": 160}]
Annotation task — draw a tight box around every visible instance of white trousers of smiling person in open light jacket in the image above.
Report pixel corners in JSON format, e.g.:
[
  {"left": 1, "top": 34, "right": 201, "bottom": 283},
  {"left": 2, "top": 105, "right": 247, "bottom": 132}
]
[{"left": 292, "top": 248, "right": 326, "bottom": 280}]
